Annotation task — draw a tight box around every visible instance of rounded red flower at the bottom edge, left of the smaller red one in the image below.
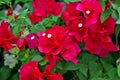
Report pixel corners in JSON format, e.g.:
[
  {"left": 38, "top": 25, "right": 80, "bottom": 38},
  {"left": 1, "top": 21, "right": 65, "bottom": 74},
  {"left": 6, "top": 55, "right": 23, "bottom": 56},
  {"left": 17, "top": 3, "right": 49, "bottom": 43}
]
[{"left": 19, "top": 61, "right": 43, "bottom": 80}]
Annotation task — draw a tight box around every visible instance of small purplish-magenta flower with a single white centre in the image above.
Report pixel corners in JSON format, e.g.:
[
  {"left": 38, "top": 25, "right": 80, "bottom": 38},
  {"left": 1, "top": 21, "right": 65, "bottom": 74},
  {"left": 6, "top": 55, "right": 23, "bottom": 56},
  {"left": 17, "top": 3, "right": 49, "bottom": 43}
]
[{"left": 25, "top": 33, "right": 38, "bottom": 49}]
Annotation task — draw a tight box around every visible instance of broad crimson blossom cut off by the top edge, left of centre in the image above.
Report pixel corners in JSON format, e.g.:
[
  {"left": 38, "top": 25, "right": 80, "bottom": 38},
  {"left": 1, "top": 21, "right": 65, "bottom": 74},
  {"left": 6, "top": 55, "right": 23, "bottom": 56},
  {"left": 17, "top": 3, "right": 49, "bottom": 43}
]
[{"left": 32, "top": 0, "right": 63, "bottom": 16}]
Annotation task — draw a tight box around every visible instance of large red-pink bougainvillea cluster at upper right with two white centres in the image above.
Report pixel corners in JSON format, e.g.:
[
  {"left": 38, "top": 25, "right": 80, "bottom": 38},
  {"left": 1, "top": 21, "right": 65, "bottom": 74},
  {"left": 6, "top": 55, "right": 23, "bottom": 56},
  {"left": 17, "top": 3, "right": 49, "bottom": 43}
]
[{"left": 62, "top": 0, "right": 119, "bottom": 57}]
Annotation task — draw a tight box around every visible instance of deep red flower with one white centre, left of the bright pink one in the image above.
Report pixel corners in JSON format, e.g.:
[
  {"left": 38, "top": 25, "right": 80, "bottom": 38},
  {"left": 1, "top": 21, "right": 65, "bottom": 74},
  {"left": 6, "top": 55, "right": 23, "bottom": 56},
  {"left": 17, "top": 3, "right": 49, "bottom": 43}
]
[{"left": 62, "top": 2, "right": 87, "bottom": 42}]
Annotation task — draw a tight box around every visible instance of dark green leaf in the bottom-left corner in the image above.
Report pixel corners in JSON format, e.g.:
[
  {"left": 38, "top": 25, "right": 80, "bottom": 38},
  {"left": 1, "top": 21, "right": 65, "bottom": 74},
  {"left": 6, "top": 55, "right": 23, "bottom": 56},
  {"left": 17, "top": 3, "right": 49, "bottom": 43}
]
[{"left": 0, "top": 67, "right": 11, "bottom": 80}]
